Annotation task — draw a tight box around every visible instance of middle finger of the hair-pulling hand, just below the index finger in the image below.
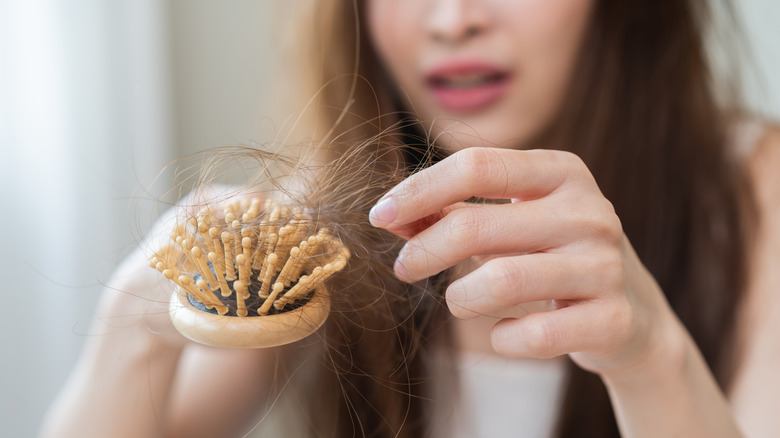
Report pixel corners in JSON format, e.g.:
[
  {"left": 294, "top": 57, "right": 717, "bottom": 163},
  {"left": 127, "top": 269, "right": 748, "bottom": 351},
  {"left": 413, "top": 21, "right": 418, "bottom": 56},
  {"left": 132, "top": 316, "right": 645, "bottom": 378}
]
[{"left": 395, "top": 198, "right": 605, "bottom": 281}]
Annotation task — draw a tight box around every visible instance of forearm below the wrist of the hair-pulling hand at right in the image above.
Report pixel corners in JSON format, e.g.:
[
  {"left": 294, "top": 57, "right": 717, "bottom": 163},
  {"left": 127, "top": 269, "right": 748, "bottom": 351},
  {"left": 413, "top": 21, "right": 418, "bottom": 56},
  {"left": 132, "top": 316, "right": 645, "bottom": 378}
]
[{"left": 602, "top": 318, "right": 742, "bottom": 438}]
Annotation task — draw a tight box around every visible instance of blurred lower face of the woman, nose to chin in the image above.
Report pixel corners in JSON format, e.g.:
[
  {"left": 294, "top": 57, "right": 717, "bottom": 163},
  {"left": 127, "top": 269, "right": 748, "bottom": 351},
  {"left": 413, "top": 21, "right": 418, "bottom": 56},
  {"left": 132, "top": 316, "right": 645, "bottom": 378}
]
[{"left": 367, "top": 0, "right": 592, "bottom": 152}]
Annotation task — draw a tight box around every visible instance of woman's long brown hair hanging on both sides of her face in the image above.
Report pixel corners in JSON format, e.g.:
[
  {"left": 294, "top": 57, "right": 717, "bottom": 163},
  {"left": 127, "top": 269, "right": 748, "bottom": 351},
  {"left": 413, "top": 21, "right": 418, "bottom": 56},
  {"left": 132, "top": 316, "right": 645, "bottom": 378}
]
[{"left": 264, "top": 0, "right": 752, "bottom": 437}]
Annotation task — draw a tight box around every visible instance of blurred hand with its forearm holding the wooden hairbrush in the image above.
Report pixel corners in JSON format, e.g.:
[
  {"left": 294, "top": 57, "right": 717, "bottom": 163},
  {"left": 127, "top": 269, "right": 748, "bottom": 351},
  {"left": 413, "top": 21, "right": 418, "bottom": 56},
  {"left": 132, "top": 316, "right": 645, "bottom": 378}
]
[{"left": 41, "top": 187, "right": 275, "bottom": 437}]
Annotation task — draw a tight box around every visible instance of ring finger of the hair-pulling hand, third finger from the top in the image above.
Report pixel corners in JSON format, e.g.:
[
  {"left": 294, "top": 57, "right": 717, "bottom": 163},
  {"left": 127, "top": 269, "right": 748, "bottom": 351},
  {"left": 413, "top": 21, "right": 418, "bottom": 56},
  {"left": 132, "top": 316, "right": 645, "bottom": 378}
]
[{"left": 446, "top": 253, "right": 603, "bottom": 319}]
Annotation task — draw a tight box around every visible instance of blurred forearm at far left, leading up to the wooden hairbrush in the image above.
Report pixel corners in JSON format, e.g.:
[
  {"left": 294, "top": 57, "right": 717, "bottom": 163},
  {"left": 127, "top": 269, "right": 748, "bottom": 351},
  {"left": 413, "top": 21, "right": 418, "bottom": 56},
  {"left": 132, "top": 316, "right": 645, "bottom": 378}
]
[{"left": 42, "top": 278, "right": 189, "bottom": 438}]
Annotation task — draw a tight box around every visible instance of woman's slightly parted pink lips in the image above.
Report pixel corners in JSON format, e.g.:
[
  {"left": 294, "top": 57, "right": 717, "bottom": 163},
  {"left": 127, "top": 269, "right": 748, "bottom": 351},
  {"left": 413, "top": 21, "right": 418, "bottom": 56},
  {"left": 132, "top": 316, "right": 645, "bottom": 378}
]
[{"left": 426, "top": 61, "right": 511, "bottom": 114}]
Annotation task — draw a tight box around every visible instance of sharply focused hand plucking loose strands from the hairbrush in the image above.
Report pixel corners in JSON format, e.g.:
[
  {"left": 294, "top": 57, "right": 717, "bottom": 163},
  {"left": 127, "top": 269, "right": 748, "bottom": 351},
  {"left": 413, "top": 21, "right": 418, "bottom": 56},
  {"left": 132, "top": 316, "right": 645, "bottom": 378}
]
[{"left": 370, "top": 148, "right": 685, "bottom": 374}]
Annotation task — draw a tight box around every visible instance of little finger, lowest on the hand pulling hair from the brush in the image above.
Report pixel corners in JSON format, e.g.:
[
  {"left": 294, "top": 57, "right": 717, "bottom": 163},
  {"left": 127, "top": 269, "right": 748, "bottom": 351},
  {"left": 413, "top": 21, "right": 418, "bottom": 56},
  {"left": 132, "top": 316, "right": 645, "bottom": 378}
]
[{"left": 490, "top": 302, "right": 631, "bottom": 359}]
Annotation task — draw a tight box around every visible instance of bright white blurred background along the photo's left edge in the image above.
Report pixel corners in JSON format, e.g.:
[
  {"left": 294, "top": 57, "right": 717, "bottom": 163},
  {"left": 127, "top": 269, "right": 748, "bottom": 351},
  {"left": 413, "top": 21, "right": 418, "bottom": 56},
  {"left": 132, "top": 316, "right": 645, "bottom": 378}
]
[{"left": 0, "top": 0, "right": 174, "bottom": 437}]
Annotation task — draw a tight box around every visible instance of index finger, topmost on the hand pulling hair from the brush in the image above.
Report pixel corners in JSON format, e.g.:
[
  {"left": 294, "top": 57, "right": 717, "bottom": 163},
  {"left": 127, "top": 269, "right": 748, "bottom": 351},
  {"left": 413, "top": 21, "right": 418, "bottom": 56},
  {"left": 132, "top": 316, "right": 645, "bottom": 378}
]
[{"left": 369, "top": 148, "right": 589, "bottom": 231}]
